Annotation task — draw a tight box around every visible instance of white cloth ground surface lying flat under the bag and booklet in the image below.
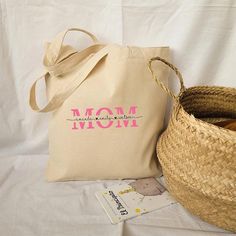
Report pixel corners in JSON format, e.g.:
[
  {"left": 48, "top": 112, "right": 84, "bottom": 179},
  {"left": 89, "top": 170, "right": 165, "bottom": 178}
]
[{"left": 0, "top": 155, "right": 233, "bottom": 236}]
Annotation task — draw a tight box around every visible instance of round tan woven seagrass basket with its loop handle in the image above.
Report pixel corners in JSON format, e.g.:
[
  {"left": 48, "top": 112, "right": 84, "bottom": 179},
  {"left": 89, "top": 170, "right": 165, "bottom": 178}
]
[{"left": 149, "top": 57, "right": 236, "bottom": 231}]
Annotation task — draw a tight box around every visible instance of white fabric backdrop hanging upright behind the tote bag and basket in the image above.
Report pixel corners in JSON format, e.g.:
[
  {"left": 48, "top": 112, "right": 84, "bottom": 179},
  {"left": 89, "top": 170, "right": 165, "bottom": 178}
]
[{"left": 0, "top": 0, "right": 236, "bottom": 155}]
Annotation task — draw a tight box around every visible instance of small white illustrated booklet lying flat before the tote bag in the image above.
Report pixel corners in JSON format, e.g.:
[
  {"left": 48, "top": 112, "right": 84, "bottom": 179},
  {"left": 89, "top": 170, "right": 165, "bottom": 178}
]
[{"left": 96, "top": 180, "right": 176, "bottom": 224}]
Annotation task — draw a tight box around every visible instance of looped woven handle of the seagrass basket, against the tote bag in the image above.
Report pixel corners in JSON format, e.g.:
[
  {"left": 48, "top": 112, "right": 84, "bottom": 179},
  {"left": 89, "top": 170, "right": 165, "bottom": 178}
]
[{"left": 148, "top": 57, "right": 185, "bottom": 102}]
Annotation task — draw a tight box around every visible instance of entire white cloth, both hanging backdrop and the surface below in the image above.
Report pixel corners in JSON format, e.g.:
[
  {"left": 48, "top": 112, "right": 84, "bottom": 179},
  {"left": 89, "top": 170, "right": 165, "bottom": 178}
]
[{"left": 0, "top": 0, "right": 236, "bottom": 236}]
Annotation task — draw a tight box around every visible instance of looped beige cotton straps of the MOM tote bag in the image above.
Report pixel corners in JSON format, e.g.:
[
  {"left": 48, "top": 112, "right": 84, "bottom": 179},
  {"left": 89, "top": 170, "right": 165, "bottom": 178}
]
[{"left": 29, "top": 28, "right": 112, "bottom": 112}]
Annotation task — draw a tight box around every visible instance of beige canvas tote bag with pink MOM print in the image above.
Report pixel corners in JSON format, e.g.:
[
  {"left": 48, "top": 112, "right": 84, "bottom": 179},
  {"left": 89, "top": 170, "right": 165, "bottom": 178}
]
[{"left": 30, "top": 28, "right": 169, "bottom": 181}]
